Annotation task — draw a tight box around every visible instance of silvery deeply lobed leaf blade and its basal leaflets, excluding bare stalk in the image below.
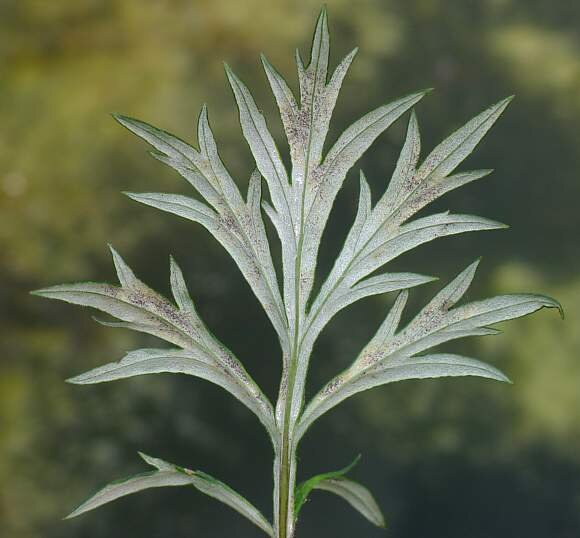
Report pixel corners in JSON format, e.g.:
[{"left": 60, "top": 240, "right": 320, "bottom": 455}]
[{"left": 34, "top": 6, "right": 561, "bottom": 536}]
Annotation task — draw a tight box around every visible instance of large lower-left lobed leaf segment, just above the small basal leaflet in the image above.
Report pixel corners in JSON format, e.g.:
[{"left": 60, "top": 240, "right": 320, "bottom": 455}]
[{"left": 34, "top": 249, "right": 275, "bottom": 435}]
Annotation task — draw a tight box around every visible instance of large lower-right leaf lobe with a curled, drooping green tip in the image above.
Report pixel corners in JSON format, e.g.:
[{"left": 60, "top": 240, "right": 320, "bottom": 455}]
[{"left": 297, "top": 261, "right": 562, "bottom": 437}]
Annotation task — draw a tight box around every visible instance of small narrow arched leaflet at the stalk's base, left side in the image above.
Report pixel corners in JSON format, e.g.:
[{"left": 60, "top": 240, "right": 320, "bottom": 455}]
[{"left": 67, "top": 453, "right": 274, "bottom": 537}]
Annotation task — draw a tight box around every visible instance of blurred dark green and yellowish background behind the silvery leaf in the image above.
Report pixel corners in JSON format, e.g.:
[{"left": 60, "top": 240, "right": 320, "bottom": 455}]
[{"left": 0, "top": 0, "right": 580, "bottom": 538}]
